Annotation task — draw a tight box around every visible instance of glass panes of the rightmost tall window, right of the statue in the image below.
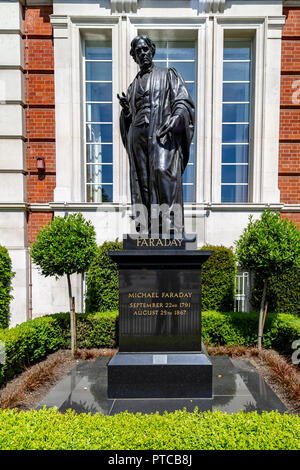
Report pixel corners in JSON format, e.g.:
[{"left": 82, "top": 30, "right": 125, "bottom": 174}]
[{"left": 221, "top": 39, "right": 252, "bottom": 203}]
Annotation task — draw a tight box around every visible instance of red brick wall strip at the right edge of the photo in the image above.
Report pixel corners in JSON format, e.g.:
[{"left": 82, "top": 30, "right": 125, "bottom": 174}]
[{"left": 279, "top": 8, "right": 300, "bottom": 213}]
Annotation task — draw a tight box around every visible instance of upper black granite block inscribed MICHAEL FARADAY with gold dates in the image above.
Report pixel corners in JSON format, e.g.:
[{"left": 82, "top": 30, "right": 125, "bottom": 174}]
[{"left": 109, "top": 250, "right": 211, "bottom": 352}]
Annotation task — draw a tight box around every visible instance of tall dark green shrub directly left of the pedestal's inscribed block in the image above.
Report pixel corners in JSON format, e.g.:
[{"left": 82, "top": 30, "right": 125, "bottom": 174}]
[{"left": 85, "top": 241, "right": 123, "bottom": 313}]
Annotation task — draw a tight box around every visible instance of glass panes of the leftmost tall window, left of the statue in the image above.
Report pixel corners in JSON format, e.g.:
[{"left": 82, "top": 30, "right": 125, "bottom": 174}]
[{"left": 85, "top": 39, "right": 113, "bottom": 198}]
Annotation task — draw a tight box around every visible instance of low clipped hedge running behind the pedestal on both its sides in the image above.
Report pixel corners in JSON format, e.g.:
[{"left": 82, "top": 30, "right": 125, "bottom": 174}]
[{"left": 0, "top": 311, "right": 300, "bottom": 384}]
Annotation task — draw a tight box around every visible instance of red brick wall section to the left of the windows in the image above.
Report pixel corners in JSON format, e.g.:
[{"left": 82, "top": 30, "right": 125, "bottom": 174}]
[{"left": 23, "top": 6, "right": 56, "bottom": 244}]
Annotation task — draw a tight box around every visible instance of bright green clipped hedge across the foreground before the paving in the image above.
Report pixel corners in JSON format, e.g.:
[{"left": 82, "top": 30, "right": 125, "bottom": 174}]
[{"left": 0, "top": 409, "right": 300, "bottom": 451}]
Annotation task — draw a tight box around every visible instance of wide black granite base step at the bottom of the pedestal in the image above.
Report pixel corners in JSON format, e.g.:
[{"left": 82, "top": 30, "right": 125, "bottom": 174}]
[{"left": 108, "top": 353, "right": 212, "bottom": 399}]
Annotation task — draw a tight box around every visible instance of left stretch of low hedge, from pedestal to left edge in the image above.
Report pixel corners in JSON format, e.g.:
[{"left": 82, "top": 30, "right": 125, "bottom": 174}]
[{"left": 0, "top": 312, "right": 118, "bottom": 384}]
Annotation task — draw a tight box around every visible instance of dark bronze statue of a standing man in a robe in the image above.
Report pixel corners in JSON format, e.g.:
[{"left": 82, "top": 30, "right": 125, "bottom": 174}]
[{"left": 118, "top": 36, "right": 194, "bottom": 233}]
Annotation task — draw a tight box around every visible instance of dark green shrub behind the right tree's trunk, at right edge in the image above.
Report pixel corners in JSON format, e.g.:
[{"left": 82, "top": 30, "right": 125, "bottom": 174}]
[{"left": 251, "top": 269, "right": 300, "bottom": 315}]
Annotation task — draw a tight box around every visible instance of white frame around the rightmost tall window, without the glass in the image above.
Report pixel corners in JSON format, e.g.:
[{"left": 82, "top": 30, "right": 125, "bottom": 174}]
[{"left": 211, "top": 18, "right": 265, "bottom": 205}]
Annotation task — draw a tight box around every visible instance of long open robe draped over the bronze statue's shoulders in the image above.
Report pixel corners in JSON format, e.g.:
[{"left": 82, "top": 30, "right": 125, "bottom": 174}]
[{"left": 120, "top": 65, "right": 194, "bottom": 231}]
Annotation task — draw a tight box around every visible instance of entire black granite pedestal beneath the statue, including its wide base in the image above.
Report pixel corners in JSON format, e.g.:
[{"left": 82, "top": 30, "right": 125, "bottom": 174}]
[{"left": 108, "top": 239, "right": 212, "bottom": 399}]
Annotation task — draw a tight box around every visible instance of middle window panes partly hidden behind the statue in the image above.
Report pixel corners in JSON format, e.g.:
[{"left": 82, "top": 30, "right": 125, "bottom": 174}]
[{"left": 154, "top": 40, "right": 196, "bottom": 202}]
